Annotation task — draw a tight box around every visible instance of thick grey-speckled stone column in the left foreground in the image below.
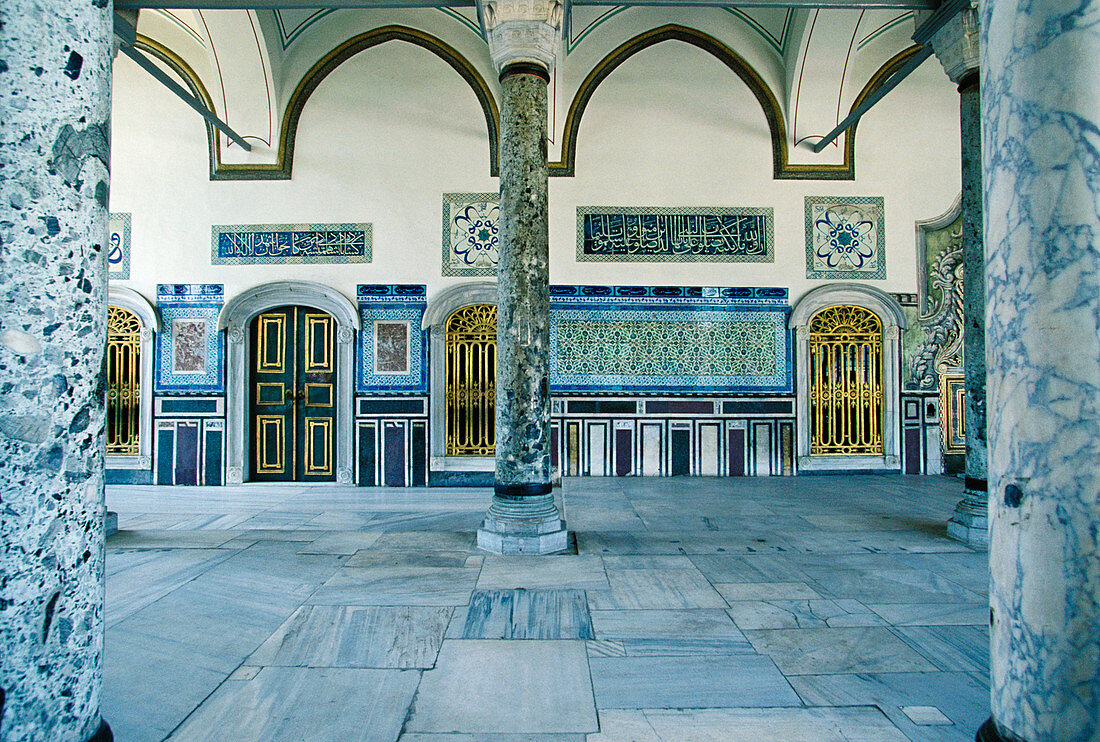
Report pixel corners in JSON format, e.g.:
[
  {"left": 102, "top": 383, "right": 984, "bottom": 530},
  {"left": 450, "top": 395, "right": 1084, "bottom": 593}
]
[{"left": 0, "top": 0, "right": 111, "bottom": 742}]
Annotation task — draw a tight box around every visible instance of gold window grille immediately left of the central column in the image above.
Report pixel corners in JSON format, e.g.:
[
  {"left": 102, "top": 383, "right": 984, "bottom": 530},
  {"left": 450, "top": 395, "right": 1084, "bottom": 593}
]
[{"left": 447, "top": 304, "right": 496, "bottom": 456}]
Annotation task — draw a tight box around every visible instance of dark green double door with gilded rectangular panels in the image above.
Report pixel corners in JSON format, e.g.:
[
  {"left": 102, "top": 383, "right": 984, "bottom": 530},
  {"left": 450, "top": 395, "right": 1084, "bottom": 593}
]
[{"left": 249, "top": 307, "right": 336, "bottom": 481}]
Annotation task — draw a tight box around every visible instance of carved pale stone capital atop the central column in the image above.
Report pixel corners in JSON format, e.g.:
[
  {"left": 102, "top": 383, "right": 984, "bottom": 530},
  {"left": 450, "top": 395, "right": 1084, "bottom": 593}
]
[{"left": 477, "top": 0, "right": 563, "bottom": 73}]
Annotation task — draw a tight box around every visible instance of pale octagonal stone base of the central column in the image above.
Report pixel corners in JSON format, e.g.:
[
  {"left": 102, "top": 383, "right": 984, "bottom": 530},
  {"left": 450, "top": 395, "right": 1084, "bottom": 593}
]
[{"left": 477, "top": 486, "right": 569, "bottom": 555}]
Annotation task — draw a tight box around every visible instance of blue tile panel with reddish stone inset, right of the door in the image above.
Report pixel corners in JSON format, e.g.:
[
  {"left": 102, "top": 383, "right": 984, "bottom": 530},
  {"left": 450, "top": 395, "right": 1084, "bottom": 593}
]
[{"left": 355, "top": 284, "right": 428, "bottom": 394}]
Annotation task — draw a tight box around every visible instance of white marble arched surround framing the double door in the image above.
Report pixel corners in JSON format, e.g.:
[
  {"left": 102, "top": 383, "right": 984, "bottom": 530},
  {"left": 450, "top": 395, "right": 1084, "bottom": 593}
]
[{"left": 218, "top": 280, "right": 360, "bottom": 485}]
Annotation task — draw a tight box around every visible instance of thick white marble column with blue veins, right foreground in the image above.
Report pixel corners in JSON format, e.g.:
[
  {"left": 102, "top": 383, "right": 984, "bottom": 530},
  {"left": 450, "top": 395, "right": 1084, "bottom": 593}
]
[{"left": 978, "top": 0, "right": 1100, "bottom": 742}]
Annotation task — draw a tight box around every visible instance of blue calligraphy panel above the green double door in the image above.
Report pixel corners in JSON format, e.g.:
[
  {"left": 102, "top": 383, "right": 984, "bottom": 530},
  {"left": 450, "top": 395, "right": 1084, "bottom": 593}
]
[{"left": 210, "top": 224, "right": 371, "bottom": 265}]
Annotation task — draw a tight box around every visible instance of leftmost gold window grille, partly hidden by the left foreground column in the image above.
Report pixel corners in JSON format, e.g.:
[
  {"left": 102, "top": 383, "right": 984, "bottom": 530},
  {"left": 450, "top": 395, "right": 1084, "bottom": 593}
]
[{"left": 107, "top": 307, "right": 141, "bottom": 456}]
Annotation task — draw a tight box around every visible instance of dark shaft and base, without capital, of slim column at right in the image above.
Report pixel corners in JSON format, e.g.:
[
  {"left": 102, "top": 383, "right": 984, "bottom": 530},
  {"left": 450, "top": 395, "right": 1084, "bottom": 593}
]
[{"left": 947, "top": 76, "right": 989, "bottom": 545}]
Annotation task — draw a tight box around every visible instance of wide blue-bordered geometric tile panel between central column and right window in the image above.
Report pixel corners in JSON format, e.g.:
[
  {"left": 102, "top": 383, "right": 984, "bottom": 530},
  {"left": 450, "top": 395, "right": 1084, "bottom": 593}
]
[{"left": 550, "top": 286, "right": 792, "bottom": 394}]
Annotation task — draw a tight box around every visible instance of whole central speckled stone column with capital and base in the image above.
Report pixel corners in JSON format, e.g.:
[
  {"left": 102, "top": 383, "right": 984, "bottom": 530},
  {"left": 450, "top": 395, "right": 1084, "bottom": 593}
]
[{"left": 477, "top": 0, "right": 568, "bottom": 554}]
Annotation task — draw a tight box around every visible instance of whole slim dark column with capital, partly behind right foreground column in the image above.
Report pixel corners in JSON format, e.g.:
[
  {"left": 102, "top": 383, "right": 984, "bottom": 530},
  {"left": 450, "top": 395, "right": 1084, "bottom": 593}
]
[{"left": 928, "top": 0, "right": 989, "bottom": 545}]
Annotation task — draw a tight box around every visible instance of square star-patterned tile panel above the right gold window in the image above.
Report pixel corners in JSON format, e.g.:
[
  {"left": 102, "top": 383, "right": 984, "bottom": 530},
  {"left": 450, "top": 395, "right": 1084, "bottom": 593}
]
[{"left": 806, "top": 196, "right": 887, "bottom": 279}]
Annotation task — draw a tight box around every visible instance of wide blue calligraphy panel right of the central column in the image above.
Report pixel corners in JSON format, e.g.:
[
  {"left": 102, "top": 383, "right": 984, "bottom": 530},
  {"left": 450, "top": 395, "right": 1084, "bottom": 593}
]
[{"left": 576, "top": 207, "right": 776, "bottom": 263}]
